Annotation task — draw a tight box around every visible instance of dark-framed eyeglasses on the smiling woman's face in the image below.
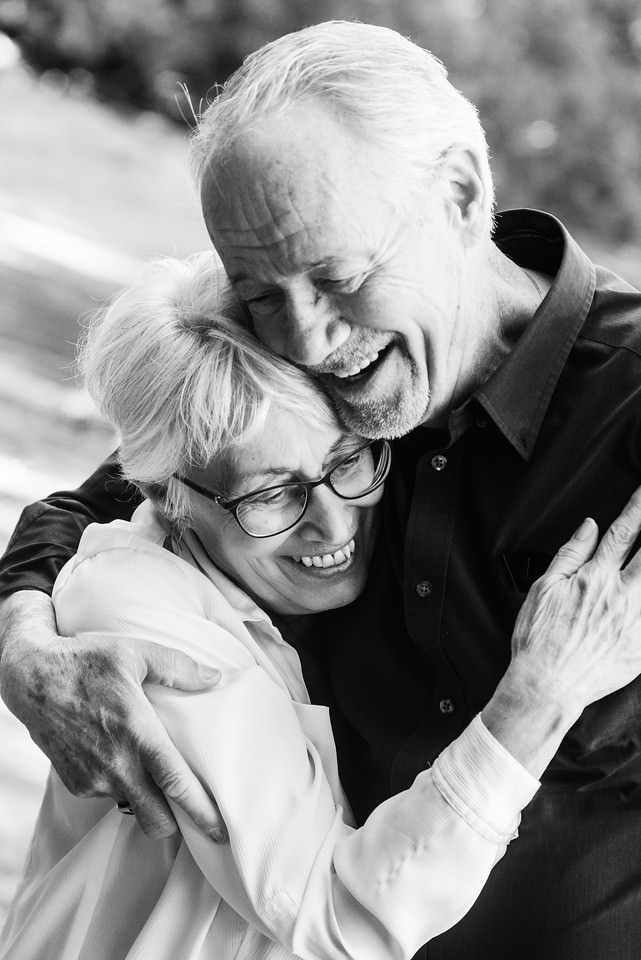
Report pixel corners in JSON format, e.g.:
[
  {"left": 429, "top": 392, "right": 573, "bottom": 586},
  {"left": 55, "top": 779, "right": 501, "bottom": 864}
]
[{"left": 174, "top": 440, "right": 392, "bottom": 539}]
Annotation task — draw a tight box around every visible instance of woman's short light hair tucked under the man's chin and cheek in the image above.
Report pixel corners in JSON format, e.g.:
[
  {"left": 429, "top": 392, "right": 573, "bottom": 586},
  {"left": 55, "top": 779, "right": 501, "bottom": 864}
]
[{"left": 79, "top": 252, "right": 336, "bottom": 522}]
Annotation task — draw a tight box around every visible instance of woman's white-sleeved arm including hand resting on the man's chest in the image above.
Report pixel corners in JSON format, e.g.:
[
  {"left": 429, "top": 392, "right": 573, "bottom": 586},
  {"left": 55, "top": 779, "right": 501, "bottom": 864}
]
[{"left": 50, "top": 494, "right": 641, "bottom": 960}]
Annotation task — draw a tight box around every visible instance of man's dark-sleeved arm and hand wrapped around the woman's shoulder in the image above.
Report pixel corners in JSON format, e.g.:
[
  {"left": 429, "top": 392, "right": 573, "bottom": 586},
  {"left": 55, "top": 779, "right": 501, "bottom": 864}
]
[{"left": 0, "top": 464, "right": 223, "bottom": 837}]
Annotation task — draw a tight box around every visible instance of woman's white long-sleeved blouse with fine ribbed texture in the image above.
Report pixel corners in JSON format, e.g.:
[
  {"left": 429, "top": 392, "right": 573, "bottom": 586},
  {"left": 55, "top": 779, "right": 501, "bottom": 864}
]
[{"left": 0, "top": 504, "right": 538, "bottom": 960}]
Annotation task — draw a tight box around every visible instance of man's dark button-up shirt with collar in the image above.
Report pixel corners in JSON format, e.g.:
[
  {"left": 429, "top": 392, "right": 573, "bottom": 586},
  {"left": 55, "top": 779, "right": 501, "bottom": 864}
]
[{"left": 0, "top": 211, "right": 641, "bottom": 960}]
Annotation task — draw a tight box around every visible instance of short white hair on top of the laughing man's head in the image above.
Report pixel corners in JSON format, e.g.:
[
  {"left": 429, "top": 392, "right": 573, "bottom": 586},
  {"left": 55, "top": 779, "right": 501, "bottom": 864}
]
[{"left": 192, "top": 20, "right": 494, "bottom": 230}]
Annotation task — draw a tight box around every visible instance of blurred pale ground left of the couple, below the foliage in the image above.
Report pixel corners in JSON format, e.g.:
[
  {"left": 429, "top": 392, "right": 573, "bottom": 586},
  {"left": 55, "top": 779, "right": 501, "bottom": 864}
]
[{"left": 0, "top": 65, "right": 209, "bottom": 928}]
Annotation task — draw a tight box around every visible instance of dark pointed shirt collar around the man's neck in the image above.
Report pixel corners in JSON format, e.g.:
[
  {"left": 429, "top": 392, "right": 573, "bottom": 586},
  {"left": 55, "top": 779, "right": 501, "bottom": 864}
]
[{"left": 474, "top": 210, "right": 596, "bottom": 460}]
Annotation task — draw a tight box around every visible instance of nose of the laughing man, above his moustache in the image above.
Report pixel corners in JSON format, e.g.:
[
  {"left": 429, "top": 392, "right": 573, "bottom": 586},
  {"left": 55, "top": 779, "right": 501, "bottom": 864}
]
[{"left": 285, "top": 288, "right": 351, "bottom": 367}]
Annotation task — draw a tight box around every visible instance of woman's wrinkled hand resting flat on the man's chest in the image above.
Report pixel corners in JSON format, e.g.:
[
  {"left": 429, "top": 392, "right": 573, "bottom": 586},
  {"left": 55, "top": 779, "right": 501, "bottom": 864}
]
[{"left": 481, "top": 488, "right": 641, "bottom": 777}]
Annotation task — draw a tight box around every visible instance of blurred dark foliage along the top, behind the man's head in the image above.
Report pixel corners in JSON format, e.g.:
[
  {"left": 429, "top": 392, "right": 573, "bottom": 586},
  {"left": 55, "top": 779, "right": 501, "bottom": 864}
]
[{"left": 0, "top": 0, "right": 641, "bottom": 243}]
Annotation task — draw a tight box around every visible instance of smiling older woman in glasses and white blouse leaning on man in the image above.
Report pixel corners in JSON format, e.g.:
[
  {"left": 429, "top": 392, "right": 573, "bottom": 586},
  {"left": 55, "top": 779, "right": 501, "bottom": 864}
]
[{"left": 0, "top": 254, "right": 636, "bottom": 960}]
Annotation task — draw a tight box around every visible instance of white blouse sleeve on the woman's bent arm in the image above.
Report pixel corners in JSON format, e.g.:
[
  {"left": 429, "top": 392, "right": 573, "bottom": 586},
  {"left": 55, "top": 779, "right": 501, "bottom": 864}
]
[{"left": 54, "top": 532, "right": 538, "bottom": 960}]
